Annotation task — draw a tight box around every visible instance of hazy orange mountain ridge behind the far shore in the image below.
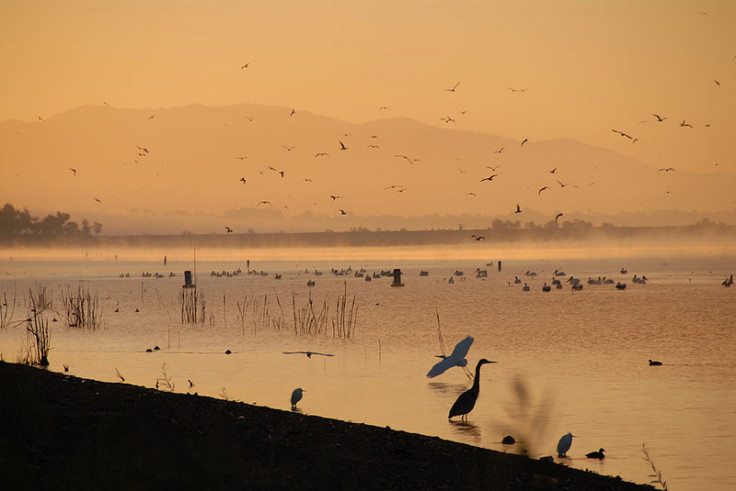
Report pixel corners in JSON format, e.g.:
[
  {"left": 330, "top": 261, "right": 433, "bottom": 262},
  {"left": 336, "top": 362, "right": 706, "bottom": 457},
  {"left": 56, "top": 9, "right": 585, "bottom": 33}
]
[{"left": 0, "top": 105, "right": 736, "bottom": 233}]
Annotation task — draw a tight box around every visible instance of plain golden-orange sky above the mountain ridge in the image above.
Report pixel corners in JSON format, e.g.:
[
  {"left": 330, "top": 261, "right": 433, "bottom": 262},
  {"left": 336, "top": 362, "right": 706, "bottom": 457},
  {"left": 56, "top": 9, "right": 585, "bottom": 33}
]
[{"left": 0, "top": 0, "right": 736, "bottom": 179}]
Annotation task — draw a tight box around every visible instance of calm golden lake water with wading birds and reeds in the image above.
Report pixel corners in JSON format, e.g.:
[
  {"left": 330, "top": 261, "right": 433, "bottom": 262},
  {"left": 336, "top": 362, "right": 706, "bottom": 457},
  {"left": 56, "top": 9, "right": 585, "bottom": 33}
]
[{"left": 0, "top": 244, "right": 736, "bottom": 490}]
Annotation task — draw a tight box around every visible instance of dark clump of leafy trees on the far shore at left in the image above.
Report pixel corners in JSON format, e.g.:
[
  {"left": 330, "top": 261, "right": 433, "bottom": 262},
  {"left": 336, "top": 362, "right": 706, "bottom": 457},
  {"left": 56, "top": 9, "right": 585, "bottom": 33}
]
[{"left": 0, "top": 203, "right": 102, "bottom": 238}]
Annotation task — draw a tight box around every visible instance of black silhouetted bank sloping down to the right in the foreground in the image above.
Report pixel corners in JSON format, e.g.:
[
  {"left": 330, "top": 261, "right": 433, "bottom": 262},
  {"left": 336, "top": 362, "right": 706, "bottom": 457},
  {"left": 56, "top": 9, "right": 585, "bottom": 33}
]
[{"left": 0, "top": 362, "right": 651, "bottom": 490}]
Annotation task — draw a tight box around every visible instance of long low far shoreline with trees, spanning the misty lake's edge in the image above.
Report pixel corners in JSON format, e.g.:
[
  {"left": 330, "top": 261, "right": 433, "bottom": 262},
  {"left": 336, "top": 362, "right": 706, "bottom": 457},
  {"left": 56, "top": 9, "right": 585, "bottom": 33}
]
[{"left": 0, "top": 204, "right": 736, "bottom": 247}]
